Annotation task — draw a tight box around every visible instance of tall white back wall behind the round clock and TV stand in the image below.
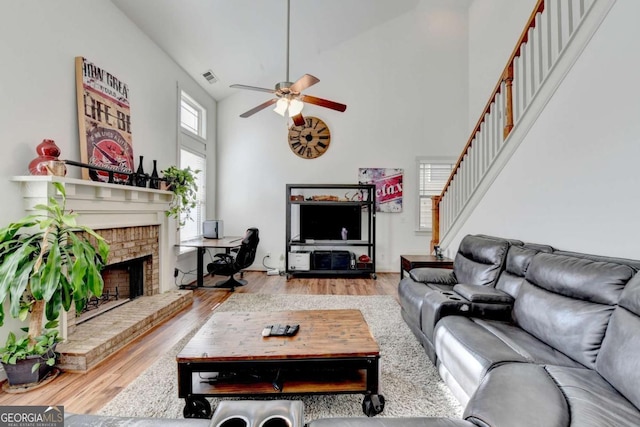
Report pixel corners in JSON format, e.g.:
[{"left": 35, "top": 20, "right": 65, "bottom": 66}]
[{"left": 218, "top": 0, "right": 468, "bottom": 271}]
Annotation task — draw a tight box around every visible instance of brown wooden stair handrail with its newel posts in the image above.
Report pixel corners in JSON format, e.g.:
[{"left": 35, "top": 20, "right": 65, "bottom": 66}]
[{"left": 431, "top": 0, "right": 545, "bottom": 251}]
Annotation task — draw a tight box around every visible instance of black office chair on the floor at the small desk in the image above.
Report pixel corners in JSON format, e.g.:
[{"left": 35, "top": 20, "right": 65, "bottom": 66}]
[{"left": 207, "top": 228, "right": 260, "bottom": 291}]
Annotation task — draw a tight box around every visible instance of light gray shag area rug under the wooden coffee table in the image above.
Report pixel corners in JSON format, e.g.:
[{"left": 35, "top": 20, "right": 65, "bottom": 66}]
[{"left": 100, "top": 293, "right": 462, "bottom": 421}]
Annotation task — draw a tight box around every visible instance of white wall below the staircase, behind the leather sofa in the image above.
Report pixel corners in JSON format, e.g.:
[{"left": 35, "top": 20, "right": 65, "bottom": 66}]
[{"left": 451, "top": 0, "right": 640, "bottom": 259}]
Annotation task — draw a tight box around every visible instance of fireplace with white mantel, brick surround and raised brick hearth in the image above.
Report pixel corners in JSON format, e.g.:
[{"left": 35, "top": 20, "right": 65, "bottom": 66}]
[{"left": 12, "top": 176, "right": 192, "bottom": 372}]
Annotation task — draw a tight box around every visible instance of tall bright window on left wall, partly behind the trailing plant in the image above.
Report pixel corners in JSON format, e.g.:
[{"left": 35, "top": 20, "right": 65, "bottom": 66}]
[{"left": 178, "top": 91, "right": 207, "bottom": 241}]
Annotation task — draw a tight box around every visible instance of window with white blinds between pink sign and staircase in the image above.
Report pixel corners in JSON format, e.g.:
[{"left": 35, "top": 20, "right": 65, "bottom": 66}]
[{"left": 418, "top": 158, "right": 455, "bottom": 231}]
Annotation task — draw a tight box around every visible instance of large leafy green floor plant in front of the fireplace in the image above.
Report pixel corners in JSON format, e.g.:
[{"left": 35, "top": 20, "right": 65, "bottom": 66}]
[{"left": 0, "top": 183, "right": 109, "bottom": 385}]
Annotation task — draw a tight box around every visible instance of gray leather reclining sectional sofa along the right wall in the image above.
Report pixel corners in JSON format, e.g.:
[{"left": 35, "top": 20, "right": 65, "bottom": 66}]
[{"left": 68, "top": 235, "right": 640, "bottom": 427}]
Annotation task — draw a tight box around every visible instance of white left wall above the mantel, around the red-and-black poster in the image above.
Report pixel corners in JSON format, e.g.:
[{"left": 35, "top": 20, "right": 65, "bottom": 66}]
[{"left": 0, "top": 0, "right": 216, "bottom": 342}]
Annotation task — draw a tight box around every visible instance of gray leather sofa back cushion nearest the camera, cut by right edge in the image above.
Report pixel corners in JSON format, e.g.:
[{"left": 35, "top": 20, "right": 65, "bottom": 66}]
[{"left": 596, "top": 275, "right": 640, "bottom": 412}]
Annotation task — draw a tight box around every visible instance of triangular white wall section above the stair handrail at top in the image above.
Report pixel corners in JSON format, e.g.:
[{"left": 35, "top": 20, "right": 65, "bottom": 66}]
[{"left": 469, "top": 0, "right": 537, "bottom": 132}]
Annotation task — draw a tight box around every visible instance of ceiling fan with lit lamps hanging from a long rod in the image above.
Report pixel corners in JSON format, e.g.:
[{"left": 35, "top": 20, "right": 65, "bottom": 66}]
[{"left": 230, "top": 0, "right": 347, "bottom": 126}]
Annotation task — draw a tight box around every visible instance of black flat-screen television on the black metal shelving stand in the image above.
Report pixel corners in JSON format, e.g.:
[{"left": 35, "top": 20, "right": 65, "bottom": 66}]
[{"left": 300, "top": 204, "right": 362, "bottom": 241}]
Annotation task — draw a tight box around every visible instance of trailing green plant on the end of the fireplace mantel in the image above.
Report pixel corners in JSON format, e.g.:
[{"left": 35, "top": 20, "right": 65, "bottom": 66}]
[{"left": 162, "top": 166, "right": 200, "bottom": 227}]
